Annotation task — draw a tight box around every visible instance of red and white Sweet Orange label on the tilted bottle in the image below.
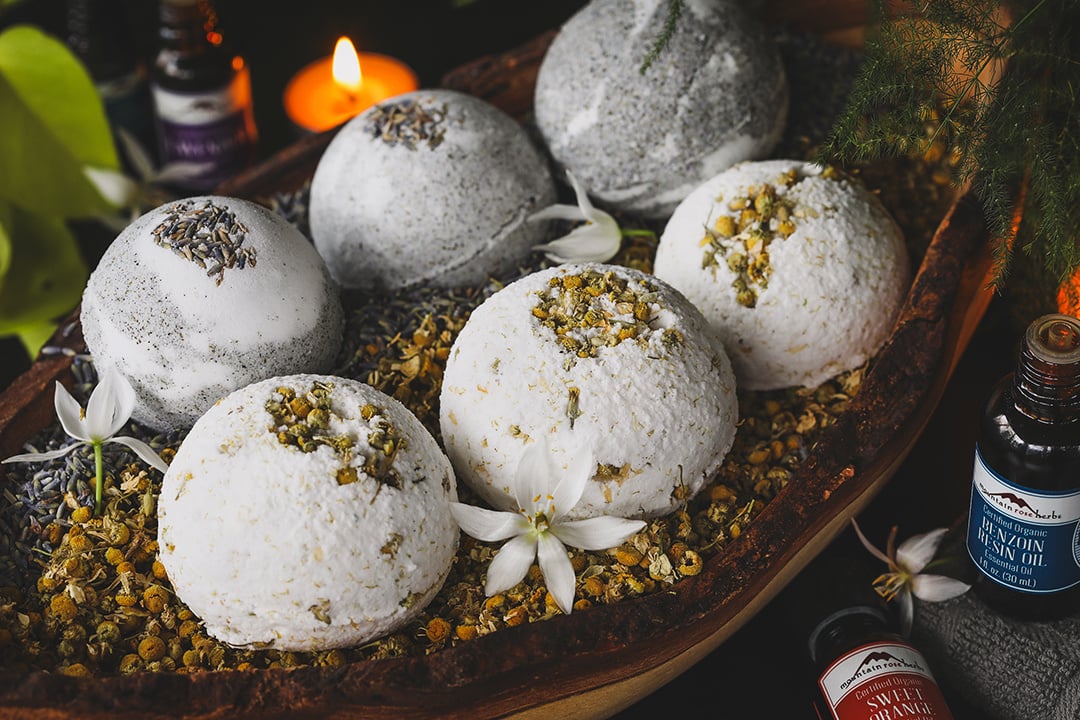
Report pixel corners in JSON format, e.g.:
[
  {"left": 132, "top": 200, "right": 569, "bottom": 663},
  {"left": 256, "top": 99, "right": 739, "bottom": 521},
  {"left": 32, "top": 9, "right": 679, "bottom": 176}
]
[{"left": 818, "top": 641, "right": 953, "bottom": 720}]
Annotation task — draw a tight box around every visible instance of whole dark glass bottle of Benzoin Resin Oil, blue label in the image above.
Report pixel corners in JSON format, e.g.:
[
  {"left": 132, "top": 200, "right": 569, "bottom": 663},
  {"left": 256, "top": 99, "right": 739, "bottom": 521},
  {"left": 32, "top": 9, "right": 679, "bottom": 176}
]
[{"left": 968, "top": 314, "right": 1080, "bottom": 620}]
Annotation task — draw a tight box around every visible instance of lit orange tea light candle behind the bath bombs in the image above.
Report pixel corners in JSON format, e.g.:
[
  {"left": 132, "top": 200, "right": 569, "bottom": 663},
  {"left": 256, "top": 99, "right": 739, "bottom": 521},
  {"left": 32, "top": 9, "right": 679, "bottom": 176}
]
[{"left": 285, "top": 37, "right": 419, "bottom": 133}]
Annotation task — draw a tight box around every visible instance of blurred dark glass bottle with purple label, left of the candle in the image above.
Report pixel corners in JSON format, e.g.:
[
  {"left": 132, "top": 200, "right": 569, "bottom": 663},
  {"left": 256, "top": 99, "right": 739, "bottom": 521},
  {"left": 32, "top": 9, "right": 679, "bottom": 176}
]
[{"left": 151, "top": 0, "right": 257, "bottom": 191}]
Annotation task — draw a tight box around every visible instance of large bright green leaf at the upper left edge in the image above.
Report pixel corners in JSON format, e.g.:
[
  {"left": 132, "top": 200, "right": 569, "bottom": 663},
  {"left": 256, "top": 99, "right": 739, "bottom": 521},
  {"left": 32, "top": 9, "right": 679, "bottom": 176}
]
[{"left": 0, "top": 26, "right": 120, "bottom": 217}]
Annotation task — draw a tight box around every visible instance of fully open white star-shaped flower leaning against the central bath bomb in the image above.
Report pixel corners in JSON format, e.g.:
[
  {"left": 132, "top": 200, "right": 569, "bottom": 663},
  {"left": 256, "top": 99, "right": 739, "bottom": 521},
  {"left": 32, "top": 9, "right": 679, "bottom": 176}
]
[{"left": 450, "top": 438, "right": 645, "bottom": 615}]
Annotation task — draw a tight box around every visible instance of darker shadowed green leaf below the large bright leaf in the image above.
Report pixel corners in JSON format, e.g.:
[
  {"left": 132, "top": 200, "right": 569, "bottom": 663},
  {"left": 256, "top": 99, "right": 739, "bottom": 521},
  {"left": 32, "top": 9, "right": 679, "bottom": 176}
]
[{"left": 0, "top": 202, "right": 87, "bottom": 343}]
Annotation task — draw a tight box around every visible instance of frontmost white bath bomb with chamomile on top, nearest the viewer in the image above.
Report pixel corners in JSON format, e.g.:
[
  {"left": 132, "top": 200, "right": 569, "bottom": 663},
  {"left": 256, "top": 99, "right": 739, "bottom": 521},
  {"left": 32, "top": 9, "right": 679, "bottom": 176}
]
[{"left": 158, "top": 375, "right": 459, "bottom": 651}]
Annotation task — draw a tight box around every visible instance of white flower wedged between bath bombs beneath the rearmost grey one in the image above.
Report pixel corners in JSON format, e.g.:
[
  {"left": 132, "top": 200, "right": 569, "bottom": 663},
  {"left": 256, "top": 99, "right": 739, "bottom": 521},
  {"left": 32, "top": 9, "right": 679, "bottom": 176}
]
[{"left": 528, "top": 171, "right": 622, "bottom": 263}]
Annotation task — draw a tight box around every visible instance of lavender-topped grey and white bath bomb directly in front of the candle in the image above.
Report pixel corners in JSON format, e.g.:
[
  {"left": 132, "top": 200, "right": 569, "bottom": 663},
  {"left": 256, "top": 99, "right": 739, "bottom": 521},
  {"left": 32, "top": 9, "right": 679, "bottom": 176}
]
[{"left": 310, "top": 90, "right": 555, "bottom": 290}]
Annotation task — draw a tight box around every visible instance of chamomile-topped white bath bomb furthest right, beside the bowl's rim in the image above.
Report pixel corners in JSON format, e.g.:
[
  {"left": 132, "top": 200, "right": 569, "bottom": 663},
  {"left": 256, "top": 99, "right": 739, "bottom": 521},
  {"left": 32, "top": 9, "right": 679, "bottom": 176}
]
[{"left": 653, "top": 160, "right": 910, "bottom": 390}]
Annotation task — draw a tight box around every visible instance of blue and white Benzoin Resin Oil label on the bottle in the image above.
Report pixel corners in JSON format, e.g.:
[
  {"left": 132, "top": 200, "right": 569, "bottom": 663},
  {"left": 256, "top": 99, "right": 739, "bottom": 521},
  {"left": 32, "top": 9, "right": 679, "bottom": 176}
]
[{"left": 968, "top": 448, "right": 1080, "bottom": 593}]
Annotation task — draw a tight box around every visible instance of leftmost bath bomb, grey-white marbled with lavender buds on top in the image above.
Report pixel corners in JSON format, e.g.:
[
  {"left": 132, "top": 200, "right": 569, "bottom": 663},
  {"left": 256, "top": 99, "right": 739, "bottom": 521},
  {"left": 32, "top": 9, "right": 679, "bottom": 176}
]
[{"left": 81, "top": 195, "right": 345, "bottom": 431}]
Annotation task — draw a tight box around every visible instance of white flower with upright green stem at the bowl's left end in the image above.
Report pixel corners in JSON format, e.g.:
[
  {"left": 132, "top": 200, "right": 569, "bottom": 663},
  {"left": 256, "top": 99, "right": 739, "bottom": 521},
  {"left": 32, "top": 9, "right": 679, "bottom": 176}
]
[{"left": 3, "top": 370, "right": 168, "bottom": 512}]
